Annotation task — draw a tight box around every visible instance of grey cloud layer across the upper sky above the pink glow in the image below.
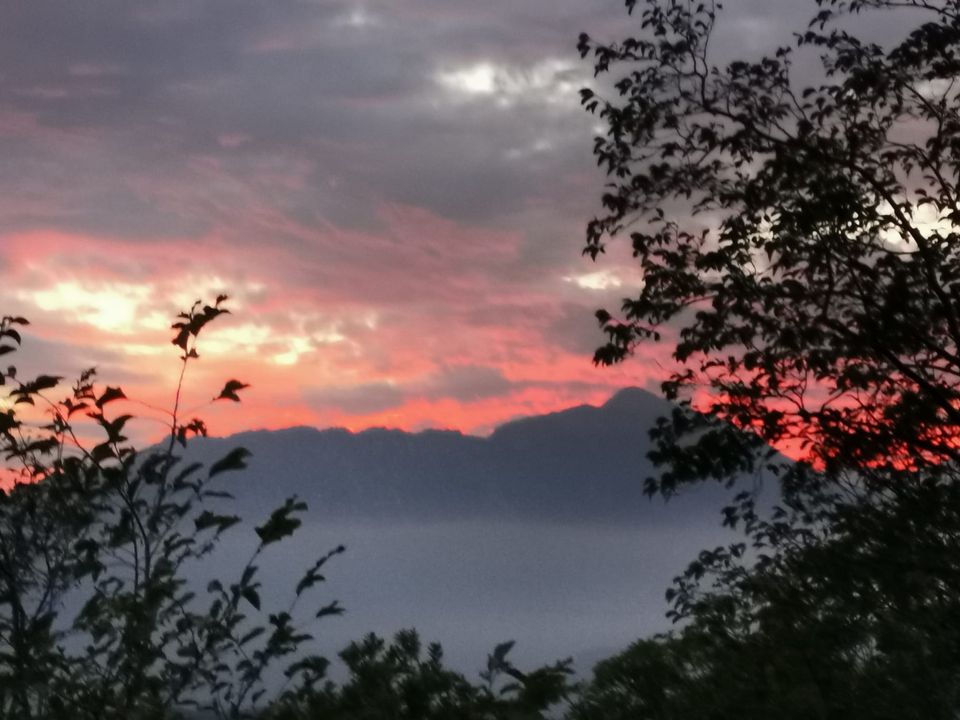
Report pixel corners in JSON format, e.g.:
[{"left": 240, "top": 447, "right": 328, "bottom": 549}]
[{"left": 0, "top": 0, "right": 916, "bottom": 300}]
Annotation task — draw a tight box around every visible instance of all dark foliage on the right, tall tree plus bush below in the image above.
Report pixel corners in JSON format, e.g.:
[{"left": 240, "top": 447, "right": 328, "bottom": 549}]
[{"left": 571, "top": 0, "right": 960, "bottom": 720}]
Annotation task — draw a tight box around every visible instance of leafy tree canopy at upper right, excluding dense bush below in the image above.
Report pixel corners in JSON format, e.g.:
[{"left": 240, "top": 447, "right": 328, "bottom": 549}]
[{"left": 579, "top": 0, "right": 960, "bottom": 491}]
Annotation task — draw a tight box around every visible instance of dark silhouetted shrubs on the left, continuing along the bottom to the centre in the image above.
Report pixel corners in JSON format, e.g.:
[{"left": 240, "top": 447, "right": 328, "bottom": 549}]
[{"left": 0, "top": 306, "right": 571, "bottom": 720}]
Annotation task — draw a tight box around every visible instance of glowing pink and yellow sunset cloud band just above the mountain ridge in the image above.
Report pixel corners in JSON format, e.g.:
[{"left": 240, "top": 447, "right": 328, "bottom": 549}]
[{"left": 0, "top": 197, "right": 663, "bottom": 442}]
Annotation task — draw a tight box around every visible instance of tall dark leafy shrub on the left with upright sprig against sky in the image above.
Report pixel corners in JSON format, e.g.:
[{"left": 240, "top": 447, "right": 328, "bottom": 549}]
[{"left": 0, "top": 296, "right": 343, "bottom": 720}]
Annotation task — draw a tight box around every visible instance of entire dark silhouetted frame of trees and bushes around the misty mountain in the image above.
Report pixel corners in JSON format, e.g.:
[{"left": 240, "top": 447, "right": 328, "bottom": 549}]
[{"left": 0, "top": 0, "right": 960, "bottom": 720}]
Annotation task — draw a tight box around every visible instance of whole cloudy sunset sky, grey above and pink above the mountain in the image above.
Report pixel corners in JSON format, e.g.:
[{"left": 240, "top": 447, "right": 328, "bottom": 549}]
[{"left": 0, "top": 0, "right": 815, "bottom": 435}]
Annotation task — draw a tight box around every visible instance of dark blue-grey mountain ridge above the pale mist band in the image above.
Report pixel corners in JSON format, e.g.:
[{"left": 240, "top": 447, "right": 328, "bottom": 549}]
[{"left": 191, "top": 388, "right": 729, "bottom": 523}]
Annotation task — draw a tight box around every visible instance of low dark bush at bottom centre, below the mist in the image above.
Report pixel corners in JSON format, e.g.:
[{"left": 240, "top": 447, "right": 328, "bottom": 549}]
[{"left": 266, "top": 630, "right": 572, "bottom": 720}]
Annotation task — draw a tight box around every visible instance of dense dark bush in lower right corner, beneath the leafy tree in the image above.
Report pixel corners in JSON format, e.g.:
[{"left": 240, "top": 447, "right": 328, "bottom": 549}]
[{"left": 571, "top": 464, "right": 960, "bottom": 720}]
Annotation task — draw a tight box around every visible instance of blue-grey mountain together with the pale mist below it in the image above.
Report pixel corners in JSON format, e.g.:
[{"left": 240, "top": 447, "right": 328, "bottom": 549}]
[{"left": 171, "top": 389, "right": 756, "bottom": 675}]
